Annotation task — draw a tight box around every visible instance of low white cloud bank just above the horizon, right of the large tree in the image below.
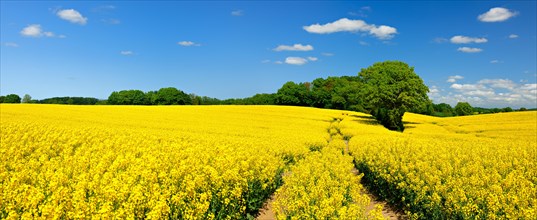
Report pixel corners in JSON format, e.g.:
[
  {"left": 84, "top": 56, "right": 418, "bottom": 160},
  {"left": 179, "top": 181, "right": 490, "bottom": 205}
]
[{"left": 444, "top": 79, "right": 537, "bottom": 108}]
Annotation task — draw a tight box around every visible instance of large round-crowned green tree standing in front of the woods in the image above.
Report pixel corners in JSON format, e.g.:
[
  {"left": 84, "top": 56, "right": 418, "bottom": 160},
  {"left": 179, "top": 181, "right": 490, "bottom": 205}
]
[{"left": 359, "top": 61, "right": 430, "bottom": 131}]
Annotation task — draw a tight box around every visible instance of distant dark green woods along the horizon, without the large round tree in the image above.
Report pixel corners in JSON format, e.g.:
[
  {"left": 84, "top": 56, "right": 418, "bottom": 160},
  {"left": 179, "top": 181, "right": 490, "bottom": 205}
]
[{"left": 0, "top": 76, "right": 535, "bottom": 117}]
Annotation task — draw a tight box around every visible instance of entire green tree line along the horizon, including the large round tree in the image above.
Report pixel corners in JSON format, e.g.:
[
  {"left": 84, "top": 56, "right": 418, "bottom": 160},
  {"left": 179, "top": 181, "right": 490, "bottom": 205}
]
[{"left": 0, "top": 61, "right": 526, "bottom": 131}]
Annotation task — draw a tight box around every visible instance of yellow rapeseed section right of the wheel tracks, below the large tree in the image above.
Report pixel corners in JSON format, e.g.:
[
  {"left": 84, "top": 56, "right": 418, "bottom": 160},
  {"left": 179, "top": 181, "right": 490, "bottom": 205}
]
[{"left": 341, "top": 111, "right": 537, "bottom": 219}]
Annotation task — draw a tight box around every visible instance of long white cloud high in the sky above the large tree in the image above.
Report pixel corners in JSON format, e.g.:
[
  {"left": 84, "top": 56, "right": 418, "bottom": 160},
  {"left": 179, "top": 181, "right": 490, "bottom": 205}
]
[{"left": 303, "top": 18, "right": 397, "bottom": 39}]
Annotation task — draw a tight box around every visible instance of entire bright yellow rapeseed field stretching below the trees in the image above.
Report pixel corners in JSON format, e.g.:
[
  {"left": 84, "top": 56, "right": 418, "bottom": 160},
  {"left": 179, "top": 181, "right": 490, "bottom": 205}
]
[{"left": 0, "top": 104, "right": 537, "bottom": 219}]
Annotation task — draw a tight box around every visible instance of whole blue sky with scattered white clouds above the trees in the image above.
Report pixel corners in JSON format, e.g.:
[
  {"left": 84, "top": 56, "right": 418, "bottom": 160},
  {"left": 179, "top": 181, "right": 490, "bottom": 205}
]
[{"left": 0, "top": 1, "right": 537, "bottom": 108}]
